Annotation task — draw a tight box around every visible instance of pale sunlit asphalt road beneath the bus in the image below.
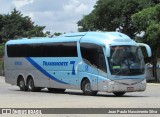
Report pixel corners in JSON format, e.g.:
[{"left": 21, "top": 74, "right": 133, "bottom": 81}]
[{"left": 0, "top": 76, "right": 160, "bottom": 117}]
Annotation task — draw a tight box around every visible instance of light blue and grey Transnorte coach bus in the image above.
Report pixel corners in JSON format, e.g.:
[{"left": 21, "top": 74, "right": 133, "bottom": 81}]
[{"left": 4, "top": 32, "right": 151, "bottom": 96}]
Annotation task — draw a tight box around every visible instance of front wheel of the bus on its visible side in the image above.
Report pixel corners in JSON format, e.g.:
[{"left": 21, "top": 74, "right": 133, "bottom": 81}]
[{"left": 82, "top": 80, "right": 98, "bottom": 96}]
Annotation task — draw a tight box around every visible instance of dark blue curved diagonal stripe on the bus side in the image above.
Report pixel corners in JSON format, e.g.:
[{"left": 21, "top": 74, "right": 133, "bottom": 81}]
[{"left": 26, "top": 57, "right": 69, "bottom": 84}]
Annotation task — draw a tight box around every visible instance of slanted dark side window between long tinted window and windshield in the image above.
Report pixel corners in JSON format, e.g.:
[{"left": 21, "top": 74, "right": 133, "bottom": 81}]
[{"left": 80, "top": 43, "right": 107, "bottom": 72}]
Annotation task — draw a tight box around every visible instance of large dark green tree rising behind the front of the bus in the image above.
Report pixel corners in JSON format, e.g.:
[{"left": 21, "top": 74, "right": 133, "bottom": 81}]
[{"left": 78, "top": 0, "right": 149, "bottom": 38}]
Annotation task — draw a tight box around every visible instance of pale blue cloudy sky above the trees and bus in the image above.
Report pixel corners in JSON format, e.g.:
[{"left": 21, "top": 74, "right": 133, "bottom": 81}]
[{"left": 0, "top": 0, "right": 97, "bottom": 33}]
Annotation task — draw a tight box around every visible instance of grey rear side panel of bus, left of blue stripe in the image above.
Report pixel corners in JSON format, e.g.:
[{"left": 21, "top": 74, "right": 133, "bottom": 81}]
[{"left": 5, "top": 58, "right": 49, "bottom": 87}]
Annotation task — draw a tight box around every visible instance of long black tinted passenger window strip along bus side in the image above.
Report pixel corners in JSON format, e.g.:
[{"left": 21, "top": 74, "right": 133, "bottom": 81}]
[{"left": 7, "top": 42, "right": 78, "bottom": 57}]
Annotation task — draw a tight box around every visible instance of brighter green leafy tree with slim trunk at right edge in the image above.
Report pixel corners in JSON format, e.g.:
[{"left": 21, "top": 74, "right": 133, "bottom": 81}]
[{"left": 132, "top": 4, "right": 160, "bottom": 81}]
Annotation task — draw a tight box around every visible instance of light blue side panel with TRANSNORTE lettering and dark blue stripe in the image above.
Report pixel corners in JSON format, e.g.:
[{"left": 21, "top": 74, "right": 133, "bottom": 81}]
[{"left": 27, "top": 57, "right": 79, "bottom": 88}]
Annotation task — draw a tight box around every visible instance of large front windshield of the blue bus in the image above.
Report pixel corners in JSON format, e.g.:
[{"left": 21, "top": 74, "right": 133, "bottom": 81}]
[{"left": 108, "top": 46, "right": 145, "bottom": 76}]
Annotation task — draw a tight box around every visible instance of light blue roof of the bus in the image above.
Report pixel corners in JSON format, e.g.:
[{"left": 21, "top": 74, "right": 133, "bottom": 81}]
[{"left": 6, "top": 32, "right": 135, "bottom": 45}]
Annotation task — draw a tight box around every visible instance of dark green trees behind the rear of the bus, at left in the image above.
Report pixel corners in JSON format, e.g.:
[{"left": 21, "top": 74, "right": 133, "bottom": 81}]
[{"left": 0, "top": 9, "right": 45, "bottom": 43}]
